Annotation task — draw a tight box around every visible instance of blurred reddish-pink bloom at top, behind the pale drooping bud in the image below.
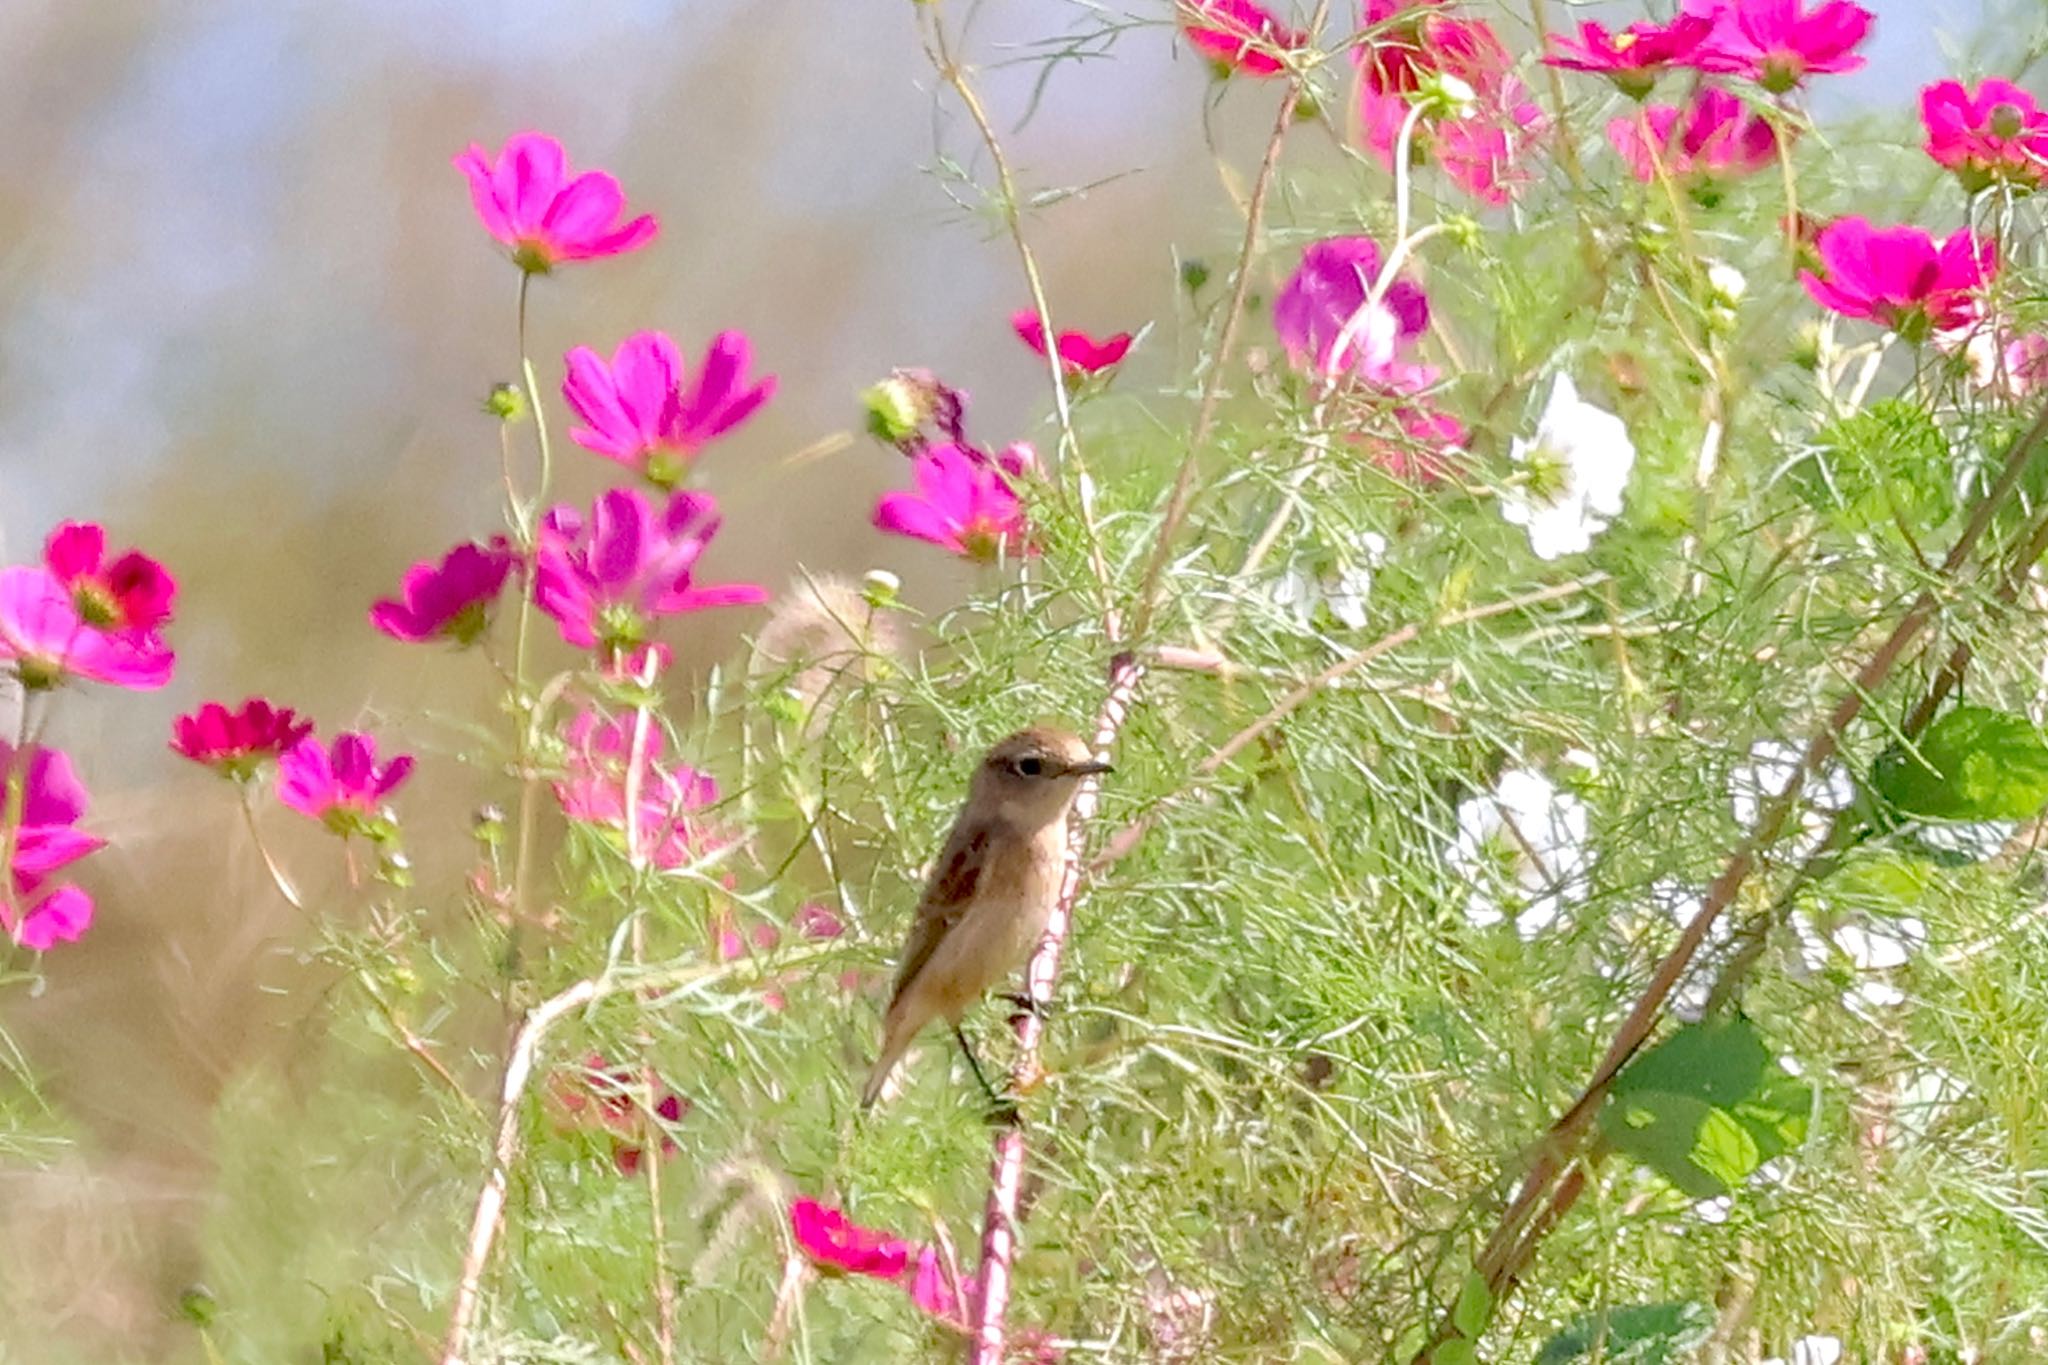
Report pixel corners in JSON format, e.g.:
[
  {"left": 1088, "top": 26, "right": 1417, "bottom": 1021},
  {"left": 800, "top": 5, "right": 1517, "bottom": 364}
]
[{"left": 1352, "top": 0, "right": 1546, "bottom": 205}]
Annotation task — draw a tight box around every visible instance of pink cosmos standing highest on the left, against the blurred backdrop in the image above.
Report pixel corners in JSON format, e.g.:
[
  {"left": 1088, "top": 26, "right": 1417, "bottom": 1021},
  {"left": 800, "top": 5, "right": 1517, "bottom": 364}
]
[{"left": 455, "top": 133, "right": 655, "bottom": 274}]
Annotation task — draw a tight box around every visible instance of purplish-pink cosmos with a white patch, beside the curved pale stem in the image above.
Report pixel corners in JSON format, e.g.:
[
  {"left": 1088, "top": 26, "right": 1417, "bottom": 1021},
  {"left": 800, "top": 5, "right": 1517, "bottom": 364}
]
[{"left": 1274, "top": 237, "right": 1436, "bottom": 393}]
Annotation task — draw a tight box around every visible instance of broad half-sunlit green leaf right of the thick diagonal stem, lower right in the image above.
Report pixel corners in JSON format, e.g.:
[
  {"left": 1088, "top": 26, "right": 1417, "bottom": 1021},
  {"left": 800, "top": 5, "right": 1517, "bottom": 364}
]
[{"left": 1599, "top": 1019, "right": 1806, "bottom": 1199}]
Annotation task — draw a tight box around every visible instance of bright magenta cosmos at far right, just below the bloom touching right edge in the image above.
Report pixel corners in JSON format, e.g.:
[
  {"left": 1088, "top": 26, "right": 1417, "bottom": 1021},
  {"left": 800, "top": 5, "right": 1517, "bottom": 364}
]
[{"left": 1798, "top": 217, "right": 1999, "bottom": 342}]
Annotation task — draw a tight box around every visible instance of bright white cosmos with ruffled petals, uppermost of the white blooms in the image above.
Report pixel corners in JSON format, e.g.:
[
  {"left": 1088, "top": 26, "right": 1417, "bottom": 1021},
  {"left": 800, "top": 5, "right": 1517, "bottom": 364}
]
[{"left": 1501, "top": 375, "right": 1636, "bottom": 559}]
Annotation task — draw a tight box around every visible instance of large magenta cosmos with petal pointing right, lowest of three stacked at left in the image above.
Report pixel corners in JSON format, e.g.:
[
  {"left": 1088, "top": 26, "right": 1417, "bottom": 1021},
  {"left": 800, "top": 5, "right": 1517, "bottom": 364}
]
[{"left": 532, "top": 489, "right": 768, "bottom": 657}]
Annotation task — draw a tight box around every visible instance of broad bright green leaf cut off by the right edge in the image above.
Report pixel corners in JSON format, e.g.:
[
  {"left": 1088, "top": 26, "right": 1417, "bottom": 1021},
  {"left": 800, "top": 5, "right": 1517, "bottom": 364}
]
[{"left": 1870, "top": 706, "right": 2048, "bottom": 821}]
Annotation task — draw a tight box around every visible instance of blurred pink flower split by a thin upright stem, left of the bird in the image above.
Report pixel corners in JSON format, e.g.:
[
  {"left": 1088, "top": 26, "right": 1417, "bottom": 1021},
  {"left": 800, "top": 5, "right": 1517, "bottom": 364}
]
[{"left": 555, "top": 710, "right": 733, "bottom": 868}]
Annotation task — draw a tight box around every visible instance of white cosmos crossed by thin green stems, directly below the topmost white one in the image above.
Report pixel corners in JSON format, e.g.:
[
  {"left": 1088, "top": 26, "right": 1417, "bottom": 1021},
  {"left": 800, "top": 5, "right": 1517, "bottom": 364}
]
[{"left": 1446, "top": 767, "right": 1589, "bottom": 939}]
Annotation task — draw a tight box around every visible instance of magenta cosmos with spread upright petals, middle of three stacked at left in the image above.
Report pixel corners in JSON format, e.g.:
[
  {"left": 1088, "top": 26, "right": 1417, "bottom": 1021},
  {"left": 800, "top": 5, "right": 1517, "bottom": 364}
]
[{"left": 561, "top": 332, "right": 776, "bottom": 489}]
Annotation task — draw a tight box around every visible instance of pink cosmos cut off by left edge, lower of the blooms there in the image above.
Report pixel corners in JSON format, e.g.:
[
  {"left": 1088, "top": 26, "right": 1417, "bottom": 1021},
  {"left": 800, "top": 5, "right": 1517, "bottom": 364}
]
[{"left": 0, "top": 741, "right": 106, "bottom": 952}]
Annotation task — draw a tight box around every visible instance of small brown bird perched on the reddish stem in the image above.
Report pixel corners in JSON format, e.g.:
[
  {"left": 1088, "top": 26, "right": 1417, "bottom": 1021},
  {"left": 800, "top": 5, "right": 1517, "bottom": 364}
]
[{"left": 860, "top": 726, "right": 1110, "bottom": 1109}]
